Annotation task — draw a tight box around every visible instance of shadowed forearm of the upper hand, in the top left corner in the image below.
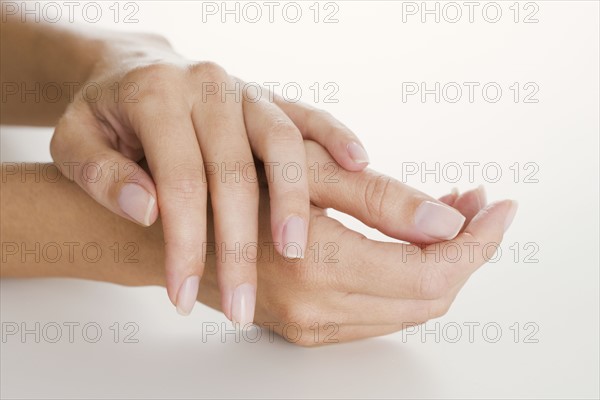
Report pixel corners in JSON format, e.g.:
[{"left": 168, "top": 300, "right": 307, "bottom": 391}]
[{"left": 0, "top": 14, "right": 103, "bottom": 125}]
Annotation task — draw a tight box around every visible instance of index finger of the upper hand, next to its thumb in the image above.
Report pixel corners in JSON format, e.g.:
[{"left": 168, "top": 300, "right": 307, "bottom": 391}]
[{"left": 127, "top": 94, "right": 207, "bottom": 315}]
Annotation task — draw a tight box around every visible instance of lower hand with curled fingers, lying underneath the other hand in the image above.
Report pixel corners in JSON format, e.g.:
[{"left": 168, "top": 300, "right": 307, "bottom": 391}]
[{"left": 200, "top": 142, "right": 516, "bottom": 346}]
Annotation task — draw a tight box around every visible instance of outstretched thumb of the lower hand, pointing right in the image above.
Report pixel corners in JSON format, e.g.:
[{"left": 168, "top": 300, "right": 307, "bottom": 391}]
[{"left": 306, "top": 142, "right": 465, "bottom": 243}]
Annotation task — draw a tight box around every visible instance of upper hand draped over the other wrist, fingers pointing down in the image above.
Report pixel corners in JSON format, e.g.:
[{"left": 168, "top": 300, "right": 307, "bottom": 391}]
[{"left": 51, "top": 32, "right": 368, "bottom": 323}]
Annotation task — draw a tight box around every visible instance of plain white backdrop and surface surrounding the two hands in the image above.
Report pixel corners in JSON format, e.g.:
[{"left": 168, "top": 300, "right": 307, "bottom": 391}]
[{"left": 0, "top": 1, "right": 599, "bottom": 398}]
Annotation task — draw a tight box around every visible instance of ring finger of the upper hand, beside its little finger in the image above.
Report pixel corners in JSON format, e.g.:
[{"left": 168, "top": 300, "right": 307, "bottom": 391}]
[{"left": 244, "top": 100, "right": 310, "bottom": 258}]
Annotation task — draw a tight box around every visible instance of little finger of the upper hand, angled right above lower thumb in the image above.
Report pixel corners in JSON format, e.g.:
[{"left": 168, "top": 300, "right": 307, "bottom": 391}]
[{"left": 236, "top": 78, "right": 369, "bottom": 171}]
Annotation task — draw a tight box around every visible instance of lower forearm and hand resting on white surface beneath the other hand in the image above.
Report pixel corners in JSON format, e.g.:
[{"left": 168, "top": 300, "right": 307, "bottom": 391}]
[{"left": 0, "top": 142, "right": 516, "bottom": 346}]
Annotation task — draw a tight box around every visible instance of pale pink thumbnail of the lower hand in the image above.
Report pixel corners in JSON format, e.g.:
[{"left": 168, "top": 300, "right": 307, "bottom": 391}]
[{"left": 415, "top": 201, "right": 465, "bottom": 240}]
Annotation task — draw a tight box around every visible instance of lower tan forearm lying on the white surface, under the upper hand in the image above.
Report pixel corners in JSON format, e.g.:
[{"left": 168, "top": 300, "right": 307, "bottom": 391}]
[{"left": 0, "top": 164, "right": 220, "bottom": 309}]
